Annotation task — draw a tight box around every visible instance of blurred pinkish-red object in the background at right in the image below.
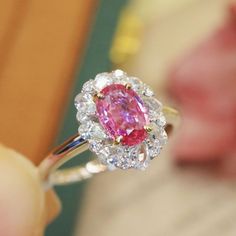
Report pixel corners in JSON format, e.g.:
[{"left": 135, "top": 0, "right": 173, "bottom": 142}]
[{"left": 168, "top": 5, "right": 236, "bottom": 164}]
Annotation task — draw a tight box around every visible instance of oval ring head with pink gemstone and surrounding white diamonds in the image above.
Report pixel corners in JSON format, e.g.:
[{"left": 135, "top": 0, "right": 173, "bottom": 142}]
[{"left": 75, "top": 70, "right": 168, "bottom": 170}]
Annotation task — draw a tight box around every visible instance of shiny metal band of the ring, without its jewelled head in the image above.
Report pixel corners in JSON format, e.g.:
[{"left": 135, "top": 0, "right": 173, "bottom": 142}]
[{"left": 39, "top": 107, "right": 179, "bottom": 188}]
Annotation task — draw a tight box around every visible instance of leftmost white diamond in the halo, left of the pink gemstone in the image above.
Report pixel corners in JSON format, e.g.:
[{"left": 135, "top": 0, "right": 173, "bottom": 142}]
[{"left": 75, "top": 93, "right": 96, "bottom": 122}]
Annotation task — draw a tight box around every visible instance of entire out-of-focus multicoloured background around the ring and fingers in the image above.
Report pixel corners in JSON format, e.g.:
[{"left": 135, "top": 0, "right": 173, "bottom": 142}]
[{"left": 0, "top": 0, "right": 236, "bottom": 236}]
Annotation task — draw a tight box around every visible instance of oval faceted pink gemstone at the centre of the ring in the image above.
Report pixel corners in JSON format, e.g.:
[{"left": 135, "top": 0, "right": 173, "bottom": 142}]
[{"left": 96, "top": 84, "right": 149, "bottom": 146}]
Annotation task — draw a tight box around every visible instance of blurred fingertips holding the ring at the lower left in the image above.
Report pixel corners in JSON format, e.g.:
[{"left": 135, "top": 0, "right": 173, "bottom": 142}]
[{"left": 0, "top": 145, "right": 60, "bottom": 236}]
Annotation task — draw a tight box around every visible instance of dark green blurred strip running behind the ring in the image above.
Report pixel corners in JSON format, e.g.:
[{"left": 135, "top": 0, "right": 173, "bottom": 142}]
[{"left": 46, "top": 0, "right": 127, "bottom": 236}]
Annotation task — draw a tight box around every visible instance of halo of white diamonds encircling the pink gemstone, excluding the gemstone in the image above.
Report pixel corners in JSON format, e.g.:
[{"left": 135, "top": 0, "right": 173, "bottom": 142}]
[{"left": 75, "top": 70, "right": 168, "bottom": 170}]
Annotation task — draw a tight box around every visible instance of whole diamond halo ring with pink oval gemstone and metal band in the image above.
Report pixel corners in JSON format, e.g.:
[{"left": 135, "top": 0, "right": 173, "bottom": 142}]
[{"left": 39, "top": 70, "right": 178, "bottom": 187}]
